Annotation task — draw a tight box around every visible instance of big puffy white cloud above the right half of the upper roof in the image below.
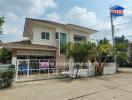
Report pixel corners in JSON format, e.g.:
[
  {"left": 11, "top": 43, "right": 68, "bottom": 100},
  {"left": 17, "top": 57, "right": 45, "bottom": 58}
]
[{"left": 66, "top": 6, "right": 98, "bottom": 27}]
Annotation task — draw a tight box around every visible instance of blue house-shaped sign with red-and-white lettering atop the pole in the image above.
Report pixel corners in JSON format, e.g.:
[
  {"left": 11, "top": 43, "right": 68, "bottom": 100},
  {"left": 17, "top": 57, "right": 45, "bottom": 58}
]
[{"left": 111, "top": 5, "right": 124, "bottom": 17}]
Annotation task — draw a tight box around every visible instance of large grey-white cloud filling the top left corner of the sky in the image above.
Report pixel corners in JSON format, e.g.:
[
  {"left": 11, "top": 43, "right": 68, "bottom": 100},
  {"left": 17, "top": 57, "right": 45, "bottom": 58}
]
[{"left": 0, "top": 0, "right": 57, "bottom": 17}]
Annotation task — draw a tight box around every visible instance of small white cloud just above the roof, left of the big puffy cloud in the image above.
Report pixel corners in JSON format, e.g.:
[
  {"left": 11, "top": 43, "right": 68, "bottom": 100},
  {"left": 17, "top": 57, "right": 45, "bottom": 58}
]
[{"left": 46, "top": 12, "right": 60, "bottom": 22}]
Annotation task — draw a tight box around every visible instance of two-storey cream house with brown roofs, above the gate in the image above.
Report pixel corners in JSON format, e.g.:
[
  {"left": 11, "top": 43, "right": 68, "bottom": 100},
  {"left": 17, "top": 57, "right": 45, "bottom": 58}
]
[{"left": 2, "top": 18, "right": 97, "bottom": 65}]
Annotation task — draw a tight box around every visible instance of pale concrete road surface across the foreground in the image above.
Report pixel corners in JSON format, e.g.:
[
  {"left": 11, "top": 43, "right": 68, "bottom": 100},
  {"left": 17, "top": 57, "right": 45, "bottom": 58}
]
[{"left": 0, "top": 69, "right": 132, "bottom": 100}]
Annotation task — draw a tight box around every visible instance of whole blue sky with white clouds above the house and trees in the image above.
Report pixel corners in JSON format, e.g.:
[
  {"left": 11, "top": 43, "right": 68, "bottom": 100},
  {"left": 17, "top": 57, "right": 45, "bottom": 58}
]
[{"left": 0, "top": 0, "right": 132, "bottom": 42}]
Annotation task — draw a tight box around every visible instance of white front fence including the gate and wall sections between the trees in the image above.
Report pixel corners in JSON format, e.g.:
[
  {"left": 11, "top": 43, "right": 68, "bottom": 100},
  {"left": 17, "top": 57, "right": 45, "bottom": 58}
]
[{"left": 16, "top": 59, "right": 116, "bottom": 81}]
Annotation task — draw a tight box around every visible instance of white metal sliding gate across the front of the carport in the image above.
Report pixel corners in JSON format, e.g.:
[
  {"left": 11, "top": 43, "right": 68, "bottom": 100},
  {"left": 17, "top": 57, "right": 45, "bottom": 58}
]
[{"left": 16, "top": 59, "right": 69, "bottom": 81}]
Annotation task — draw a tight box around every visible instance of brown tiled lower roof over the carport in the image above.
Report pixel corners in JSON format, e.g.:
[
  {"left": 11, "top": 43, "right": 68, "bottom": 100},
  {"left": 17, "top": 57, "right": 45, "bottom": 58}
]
[{"left": 1, "top": 41, "right": 57, "bottom": 50}]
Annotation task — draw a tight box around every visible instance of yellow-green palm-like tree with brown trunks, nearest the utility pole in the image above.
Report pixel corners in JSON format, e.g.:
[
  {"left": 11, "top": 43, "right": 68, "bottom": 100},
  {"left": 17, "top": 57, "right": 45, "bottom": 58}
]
[{"left": 94, "top": 38, "right": 113, "bottom": 76}]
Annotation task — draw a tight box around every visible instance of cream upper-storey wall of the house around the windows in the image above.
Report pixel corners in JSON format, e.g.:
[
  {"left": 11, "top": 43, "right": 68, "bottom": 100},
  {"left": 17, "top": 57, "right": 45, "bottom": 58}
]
[{"left": 31, "top": 26, "right": 90, "bottom": 47}]
